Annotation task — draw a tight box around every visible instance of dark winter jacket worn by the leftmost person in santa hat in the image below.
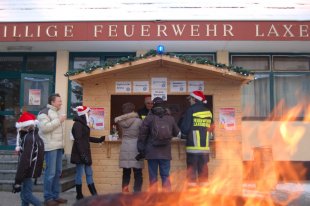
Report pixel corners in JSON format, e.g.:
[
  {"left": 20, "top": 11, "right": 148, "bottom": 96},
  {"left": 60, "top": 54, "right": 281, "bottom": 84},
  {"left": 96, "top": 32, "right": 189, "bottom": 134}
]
[{"left": 15, "top": 128, "right": 44, "bottom": 184}]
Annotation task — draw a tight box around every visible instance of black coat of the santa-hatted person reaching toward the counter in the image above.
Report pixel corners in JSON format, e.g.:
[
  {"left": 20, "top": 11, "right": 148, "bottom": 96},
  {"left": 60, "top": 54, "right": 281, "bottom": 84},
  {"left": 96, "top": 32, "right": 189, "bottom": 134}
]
[{"left": 70, "top": 115, "right": 101, "bottom": 165}]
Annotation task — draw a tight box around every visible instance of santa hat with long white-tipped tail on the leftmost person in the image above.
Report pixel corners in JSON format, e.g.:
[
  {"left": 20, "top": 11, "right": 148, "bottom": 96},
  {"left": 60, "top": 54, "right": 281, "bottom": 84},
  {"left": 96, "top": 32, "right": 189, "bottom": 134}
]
[{"left": 15, "top": 112, "right": 38, "bottom": 151}]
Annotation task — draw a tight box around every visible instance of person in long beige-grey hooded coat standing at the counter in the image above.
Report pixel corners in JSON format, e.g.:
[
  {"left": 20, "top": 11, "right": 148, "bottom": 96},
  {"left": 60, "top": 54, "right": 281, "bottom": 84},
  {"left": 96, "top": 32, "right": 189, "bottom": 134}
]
[{"left": 115, "top": 102, "right": 144, "bottom": 192}]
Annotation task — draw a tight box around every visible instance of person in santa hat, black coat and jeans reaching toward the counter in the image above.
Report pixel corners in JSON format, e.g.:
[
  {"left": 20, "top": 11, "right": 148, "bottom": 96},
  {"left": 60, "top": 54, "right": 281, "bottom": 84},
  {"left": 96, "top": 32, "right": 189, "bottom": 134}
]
[{"left": 71, "top": 106, "right": 105, "bottom": 200}]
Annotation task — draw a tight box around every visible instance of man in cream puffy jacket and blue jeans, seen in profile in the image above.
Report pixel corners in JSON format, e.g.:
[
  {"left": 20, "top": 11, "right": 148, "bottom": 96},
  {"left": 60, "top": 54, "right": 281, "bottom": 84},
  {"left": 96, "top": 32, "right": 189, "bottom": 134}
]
[{"left": 38, "top": 94, "right": 67, "bottom": 206}]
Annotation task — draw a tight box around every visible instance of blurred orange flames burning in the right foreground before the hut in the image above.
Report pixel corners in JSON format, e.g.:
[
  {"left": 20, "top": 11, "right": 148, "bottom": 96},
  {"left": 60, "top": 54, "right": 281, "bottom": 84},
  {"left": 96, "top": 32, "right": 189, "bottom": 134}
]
[{"left": 85, "top": 102, "right": 310, "bottom": 206}]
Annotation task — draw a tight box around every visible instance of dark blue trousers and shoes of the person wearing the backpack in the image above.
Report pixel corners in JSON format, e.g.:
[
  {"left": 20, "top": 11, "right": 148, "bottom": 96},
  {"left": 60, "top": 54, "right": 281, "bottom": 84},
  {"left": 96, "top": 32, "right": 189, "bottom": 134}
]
[{"left": 147, "top": 159, "right": 171, "bottom": 191}]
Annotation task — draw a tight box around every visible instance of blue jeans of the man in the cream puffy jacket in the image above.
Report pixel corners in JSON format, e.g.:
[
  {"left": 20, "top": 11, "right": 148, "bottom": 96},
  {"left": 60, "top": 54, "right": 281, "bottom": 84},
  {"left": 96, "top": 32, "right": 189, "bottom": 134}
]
[{"left": 44, "top": 149, "right": 62, "bottom": 201}]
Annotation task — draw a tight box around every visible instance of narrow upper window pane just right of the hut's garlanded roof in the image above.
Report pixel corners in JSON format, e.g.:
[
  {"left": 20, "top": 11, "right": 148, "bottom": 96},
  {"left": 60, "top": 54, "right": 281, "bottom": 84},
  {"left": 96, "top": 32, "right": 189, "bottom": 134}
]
[{"left": 231, "top": 56, "right": 270, "bottom": 71}]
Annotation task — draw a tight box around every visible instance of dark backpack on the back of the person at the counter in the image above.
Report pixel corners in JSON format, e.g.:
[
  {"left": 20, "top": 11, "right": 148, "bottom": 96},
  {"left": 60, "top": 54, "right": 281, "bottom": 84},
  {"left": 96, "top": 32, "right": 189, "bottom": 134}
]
[{"left": 151, "top": 115, "right": 172, "bottom": 146}]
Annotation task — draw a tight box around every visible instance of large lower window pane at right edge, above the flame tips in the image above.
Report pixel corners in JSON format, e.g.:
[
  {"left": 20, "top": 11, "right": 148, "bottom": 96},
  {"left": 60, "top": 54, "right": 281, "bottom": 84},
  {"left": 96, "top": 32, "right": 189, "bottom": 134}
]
[{"left": 274, "top": 73, "right": 310, "bottom": 118}]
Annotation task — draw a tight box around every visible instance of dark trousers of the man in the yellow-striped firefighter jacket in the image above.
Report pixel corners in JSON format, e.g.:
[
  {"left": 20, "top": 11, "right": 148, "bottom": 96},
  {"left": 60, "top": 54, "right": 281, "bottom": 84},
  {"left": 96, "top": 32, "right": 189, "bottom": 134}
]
[{"left": 186, "top": 153, "right": 209, "bottom": 183}]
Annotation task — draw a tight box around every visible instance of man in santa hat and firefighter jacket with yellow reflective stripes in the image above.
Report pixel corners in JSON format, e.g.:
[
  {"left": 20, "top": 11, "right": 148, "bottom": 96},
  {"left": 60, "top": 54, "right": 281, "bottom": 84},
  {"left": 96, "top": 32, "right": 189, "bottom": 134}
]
[{"left": 180, "top": 90, "right": 212, "bottom": 187}]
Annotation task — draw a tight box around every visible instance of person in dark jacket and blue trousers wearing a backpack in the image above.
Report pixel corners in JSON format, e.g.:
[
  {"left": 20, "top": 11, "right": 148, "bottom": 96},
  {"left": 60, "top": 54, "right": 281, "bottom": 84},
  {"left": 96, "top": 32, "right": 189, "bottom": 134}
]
[{"left": 137, "top": 97, "right": 179, "bottom": 191}]
